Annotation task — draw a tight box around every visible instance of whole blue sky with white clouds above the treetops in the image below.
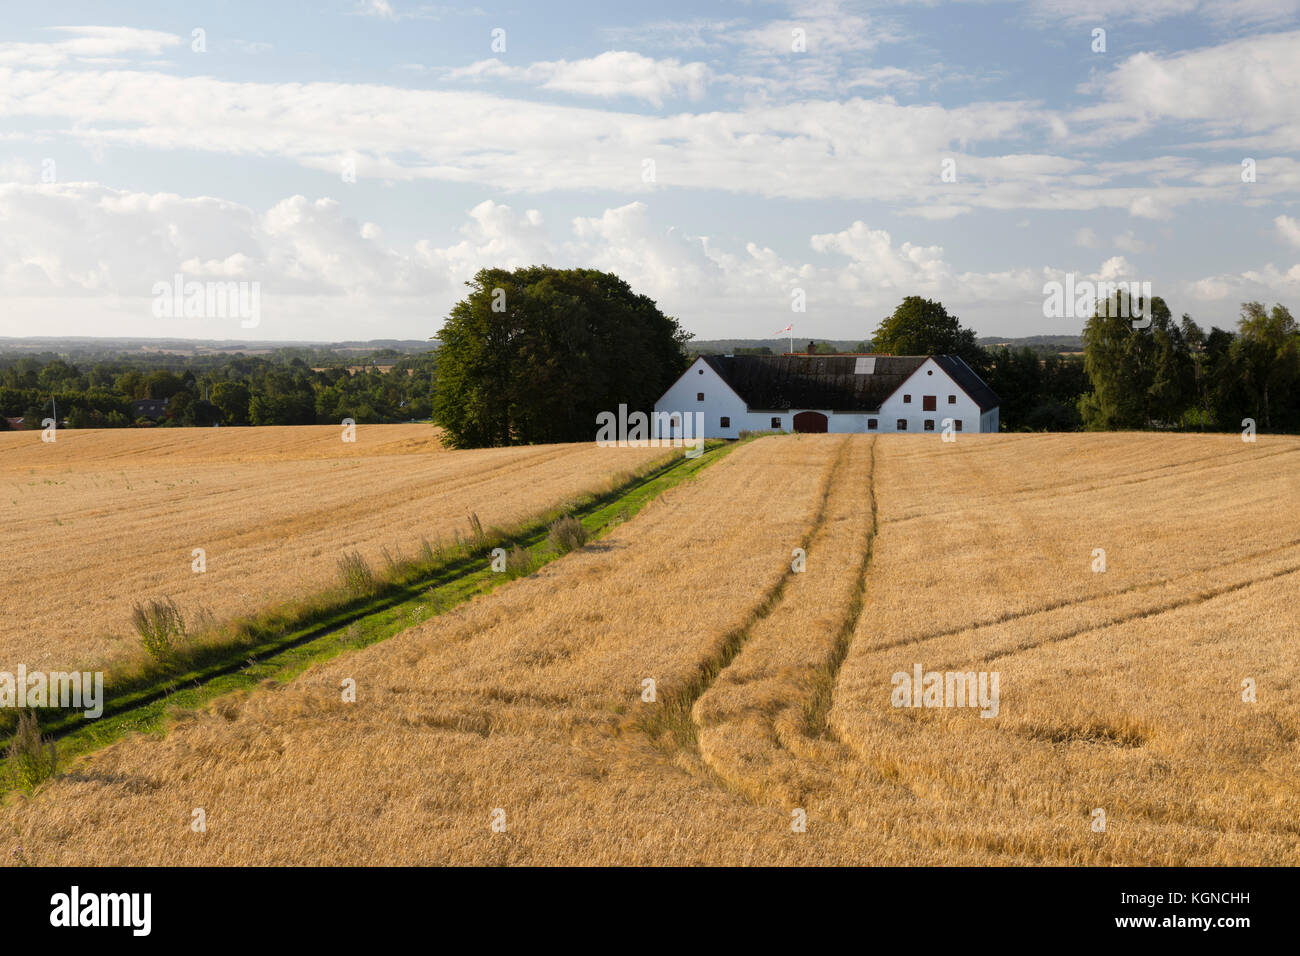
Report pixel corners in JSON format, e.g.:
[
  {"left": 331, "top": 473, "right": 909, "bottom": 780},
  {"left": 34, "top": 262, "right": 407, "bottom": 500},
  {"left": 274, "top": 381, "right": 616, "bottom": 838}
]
[{"left": 0, "top": 0, "right": 1300, "bottom": 341}]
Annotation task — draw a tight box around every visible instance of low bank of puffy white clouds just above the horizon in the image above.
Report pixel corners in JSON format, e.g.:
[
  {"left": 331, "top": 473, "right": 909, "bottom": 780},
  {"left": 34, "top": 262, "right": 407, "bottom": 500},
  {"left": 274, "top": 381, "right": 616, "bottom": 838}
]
[{"left": 0, "top": 183, "right": 1076, "bottom": 341}]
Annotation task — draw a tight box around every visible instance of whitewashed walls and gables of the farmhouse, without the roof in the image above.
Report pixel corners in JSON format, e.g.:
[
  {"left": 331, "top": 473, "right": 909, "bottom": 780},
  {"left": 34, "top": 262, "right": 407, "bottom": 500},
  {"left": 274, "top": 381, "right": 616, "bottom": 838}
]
[{"left": 654, "top": 359, "right": 997, "bottom": 438}]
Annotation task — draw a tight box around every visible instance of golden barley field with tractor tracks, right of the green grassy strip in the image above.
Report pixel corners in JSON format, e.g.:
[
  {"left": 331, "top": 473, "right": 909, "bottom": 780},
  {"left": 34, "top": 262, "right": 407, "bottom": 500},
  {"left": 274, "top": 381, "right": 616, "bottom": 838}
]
[{"left": 0, "top": 434, "right": 1300, "bottom": 865}]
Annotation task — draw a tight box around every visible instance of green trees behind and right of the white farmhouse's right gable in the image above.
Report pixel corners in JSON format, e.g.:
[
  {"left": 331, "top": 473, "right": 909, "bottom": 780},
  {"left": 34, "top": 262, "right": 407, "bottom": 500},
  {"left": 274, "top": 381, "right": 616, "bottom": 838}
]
[{"left": 872, "top": 293, "right": 1300, "bottom": 432}]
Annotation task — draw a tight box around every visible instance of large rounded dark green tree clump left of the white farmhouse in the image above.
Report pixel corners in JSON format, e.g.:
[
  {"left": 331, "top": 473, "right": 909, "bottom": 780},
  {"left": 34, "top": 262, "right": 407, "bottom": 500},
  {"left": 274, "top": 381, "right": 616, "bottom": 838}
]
[{"left": 433, "top": 265, "right": 689, "bottom": 447}]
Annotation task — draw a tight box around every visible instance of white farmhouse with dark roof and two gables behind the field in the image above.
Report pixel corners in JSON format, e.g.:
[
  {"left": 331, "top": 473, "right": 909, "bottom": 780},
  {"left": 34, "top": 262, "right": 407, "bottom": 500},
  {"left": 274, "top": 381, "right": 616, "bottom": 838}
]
[{"left": 655, "top": 355, "right": 998, "bottom": 438}]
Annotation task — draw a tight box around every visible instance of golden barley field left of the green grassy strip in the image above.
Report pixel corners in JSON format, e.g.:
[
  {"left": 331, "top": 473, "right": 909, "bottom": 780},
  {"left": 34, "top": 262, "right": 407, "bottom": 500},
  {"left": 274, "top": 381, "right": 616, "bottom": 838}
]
[{"left": 0, "top": 425, "right": 664, "bottom": 669}]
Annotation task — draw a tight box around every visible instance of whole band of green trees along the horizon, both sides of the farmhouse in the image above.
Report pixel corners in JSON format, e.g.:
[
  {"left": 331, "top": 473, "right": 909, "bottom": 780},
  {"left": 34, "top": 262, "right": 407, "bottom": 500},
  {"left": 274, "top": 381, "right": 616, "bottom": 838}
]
[{"left": 0, "top": 265, "right": 1300, "bottom": 447}]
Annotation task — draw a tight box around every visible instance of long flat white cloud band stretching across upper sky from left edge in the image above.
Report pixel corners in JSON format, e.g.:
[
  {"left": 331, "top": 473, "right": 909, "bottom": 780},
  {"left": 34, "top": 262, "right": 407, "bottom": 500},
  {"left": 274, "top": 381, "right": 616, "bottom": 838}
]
[{"left": 0, "top": 68, "right": 1066, "bottom": 206}]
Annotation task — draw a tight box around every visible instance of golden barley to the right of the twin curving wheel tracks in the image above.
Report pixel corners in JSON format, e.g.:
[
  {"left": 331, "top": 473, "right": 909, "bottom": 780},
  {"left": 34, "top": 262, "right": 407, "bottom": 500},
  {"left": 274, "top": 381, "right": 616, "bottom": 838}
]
[{"left": 831, "top": 434, "right": 1300, "bottom": 865}]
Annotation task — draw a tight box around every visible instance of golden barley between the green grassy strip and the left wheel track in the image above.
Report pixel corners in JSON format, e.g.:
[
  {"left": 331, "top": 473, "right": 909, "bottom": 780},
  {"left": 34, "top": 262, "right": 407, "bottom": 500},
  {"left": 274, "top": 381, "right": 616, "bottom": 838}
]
[{"left": 3, "top": 437, "right": 878, "bottom": 864}]
